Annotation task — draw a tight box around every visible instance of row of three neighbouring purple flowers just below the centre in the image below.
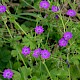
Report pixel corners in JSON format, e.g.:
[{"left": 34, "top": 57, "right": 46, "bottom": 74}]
[{"left": 22, "top": 46, "right": 50, "bottom": 59}]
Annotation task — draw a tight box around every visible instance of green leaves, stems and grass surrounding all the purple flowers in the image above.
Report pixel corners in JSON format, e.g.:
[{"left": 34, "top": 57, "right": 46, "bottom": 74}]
[{"left": 0, "top": 0, "right": 80, "bottom": 80}]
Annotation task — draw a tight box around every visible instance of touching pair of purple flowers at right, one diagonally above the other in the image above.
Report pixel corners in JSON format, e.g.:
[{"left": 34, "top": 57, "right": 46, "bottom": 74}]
[{"left": 58, "top": 32, "right": 72, "bottom": 47}]
